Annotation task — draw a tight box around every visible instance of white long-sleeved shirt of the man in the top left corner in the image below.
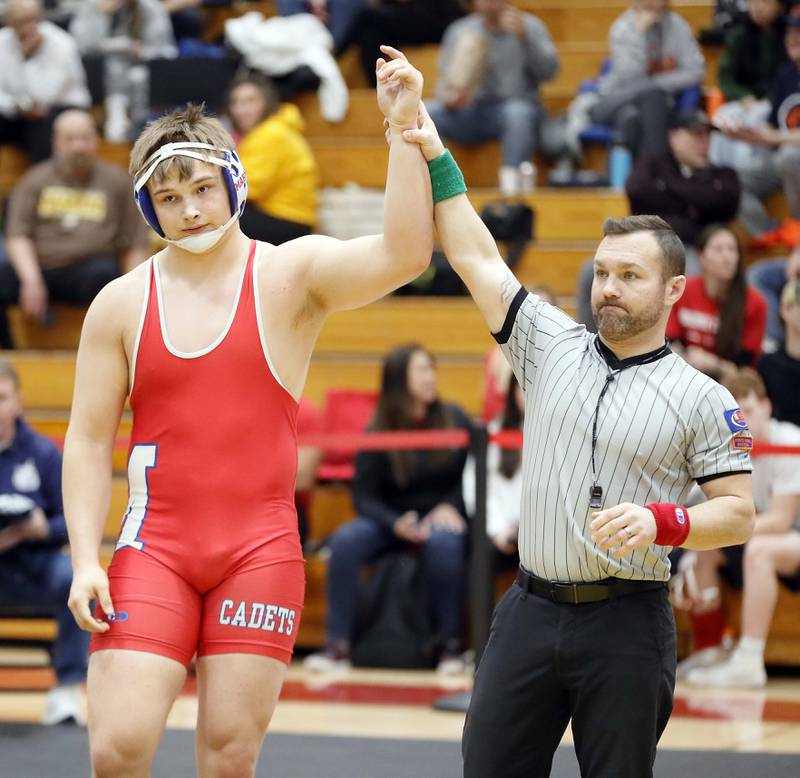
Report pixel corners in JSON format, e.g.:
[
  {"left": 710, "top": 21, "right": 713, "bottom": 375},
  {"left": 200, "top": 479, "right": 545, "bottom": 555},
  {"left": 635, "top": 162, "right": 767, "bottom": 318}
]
[{"left": 0, "top": 21, "right": 91, "bottom": 117}]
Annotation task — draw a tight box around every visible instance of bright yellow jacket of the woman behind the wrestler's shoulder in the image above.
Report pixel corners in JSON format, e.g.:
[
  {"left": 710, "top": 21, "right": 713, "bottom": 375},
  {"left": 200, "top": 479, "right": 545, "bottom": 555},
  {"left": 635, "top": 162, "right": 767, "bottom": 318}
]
[{"left": 239, "top": 103, "right": 319, "bottom": 227}]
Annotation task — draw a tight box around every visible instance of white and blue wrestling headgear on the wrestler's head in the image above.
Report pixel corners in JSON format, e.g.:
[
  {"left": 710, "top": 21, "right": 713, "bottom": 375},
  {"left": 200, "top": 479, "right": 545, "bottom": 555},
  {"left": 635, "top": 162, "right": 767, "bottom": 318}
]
[{"left": 133, "top": 141, "right": 247, "bottom": 254}]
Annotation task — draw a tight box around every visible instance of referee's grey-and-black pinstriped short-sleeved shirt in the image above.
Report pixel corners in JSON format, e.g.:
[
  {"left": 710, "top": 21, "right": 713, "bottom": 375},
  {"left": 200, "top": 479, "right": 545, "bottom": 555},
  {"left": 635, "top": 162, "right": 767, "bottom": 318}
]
[{"left": 494, "top": 289, "right": 751, "bottom": 581}]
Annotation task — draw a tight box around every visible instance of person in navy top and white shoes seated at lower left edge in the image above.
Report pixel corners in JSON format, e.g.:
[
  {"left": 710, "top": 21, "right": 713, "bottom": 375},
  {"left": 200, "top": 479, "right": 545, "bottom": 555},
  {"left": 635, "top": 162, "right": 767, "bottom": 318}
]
[{"left": 0, "top": 360, "right": 89, "bottom": 724}]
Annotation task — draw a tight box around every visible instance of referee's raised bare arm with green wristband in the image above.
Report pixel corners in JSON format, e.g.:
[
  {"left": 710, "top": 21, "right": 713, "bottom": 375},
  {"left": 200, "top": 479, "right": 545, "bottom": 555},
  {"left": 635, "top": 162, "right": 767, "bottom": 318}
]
[{"left": 403, "top": 104, "right": 521, "bottom": 332}]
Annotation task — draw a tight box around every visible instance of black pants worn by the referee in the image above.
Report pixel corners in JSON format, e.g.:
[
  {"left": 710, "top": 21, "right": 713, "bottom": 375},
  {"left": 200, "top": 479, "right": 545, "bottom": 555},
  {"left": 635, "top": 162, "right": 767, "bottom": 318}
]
[{"left": 462, "top": 584, "right": 676, "bottom": 778}]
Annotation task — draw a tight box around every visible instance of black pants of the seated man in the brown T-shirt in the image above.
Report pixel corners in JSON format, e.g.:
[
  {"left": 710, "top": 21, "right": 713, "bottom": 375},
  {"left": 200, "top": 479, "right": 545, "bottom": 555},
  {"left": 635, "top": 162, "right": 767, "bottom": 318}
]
[{"left": 0, "top": 257, "right": 119, "bottom": 348}]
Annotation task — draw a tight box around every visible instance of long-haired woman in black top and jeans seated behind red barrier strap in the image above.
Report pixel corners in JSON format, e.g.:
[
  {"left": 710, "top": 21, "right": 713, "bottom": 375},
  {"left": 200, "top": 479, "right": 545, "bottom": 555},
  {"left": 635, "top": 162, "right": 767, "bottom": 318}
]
[{"left": 306, "top": 345, "right": 470, "bottom": 671}]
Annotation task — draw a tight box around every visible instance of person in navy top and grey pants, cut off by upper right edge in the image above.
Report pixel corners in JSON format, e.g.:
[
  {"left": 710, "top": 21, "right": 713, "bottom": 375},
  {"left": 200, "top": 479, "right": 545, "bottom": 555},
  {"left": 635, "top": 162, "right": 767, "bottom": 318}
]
[{"left": 717, "top": 5, "right": 800, "bottom": 238}]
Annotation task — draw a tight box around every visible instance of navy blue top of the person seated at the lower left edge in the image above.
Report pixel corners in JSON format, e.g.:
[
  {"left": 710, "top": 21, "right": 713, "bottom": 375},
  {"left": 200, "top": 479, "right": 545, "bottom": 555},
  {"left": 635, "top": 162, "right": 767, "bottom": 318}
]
[{"left": 0, "top": 419, "right": 67, "bottom": 546}]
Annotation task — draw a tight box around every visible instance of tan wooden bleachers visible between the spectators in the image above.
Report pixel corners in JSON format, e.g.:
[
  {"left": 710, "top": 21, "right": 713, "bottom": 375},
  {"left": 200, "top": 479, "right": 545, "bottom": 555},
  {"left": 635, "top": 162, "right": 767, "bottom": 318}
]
[{"left": 0, "top": 0, "right": 800, "bottom": 664}]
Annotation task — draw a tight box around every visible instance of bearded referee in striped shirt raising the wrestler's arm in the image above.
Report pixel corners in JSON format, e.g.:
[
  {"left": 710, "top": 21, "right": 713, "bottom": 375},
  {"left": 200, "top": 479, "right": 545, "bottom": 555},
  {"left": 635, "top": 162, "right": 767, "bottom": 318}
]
[{"left": 406, "top": 103, "right": 753, "bottom": 778}]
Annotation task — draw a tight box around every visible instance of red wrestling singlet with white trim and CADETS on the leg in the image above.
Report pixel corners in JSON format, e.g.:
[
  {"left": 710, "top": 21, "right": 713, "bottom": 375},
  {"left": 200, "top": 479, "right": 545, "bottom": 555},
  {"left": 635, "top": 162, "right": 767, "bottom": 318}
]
[{"left": 92, "top": 242, "right": 304, "bottom": 663}]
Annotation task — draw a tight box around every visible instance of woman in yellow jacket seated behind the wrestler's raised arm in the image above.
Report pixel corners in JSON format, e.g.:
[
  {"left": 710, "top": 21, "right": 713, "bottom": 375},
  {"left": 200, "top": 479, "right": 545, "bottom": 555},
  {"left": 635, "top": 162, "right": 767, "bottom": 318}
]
[{"left": 228, "top": 75, "right": 319, "bottom": 244}]
